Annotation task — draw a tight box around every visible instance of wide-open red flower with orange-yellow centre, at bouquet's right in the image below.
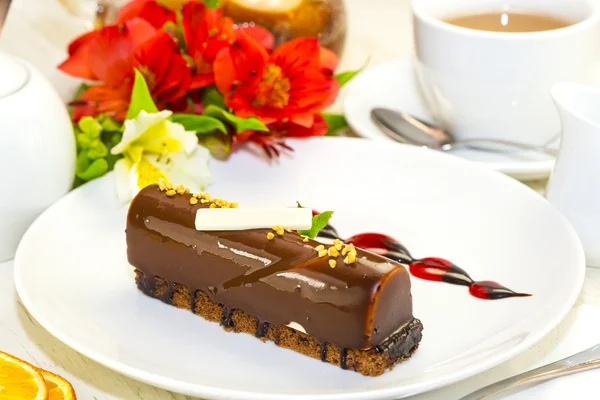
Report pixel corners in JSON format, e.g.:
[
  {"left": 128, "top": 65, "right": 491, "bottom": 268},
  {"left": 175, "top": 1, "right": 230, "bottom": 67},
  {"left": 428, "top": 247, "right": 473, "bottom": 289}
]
[{"left": 214, "top": 34, "right": 339, "bottom": 130}]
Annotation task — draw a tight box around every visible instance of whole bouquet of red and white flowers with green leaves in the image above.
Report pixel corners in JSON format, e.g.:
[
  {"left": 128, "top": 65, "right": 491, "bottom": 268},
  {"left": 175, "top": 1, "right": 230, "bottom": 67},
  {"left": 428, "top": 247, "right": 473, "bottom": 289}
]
[{"left": 59, "top": 0, "right": 358, "bottom": 201}]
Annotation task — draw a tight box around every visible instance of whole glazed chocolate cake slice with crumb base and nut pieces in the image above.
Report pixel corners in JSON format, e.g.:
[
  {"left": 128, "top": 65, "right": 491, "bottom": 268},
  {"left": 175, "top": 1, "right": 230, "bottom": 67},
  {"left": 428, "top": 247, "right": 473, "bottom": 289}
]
[{"left": 126, "top": 185, "right": 423, "bottom": 376}]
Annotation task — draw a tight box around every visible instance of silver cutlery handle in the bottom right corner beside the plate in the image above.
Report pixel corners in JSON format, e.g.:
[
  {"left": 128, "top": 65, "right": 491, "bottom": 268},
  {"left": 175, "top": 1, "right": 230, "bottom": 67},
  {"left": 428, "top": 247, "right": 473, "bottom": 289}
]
[{"left": 459, "top": 344, "right": 600, "bottom": 400}]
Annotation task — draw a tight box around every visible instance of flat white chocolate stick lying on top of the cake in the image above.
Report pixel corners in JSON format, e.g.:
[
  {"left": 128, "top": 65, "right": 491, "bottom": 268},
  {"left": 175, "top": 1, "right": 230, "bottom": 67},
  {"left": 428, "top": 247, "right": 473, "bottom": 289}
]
[{"left": 196, "top": 207, "right": 312, "bottom": 231}]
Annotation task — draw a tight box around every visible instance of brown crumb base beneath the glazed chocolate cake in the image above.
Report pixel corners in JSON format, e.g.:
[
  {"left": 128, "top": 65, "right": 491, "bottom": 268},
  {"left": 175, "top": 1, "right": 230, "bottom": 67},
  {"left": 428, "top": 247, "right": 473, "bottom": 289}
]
[{"left": 135, "top": 269, "right": 423, "bottom": 376}]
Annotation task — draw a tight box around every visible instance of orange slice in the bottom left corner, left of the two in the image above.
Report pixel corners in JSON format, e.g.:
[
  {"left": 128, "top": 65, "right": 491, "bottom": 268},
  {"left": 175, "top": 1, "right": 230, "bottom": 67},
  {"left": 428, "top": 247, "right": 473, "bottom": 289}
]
[{"left": 0, "top": 351, "right": 48, "bottom": 400}]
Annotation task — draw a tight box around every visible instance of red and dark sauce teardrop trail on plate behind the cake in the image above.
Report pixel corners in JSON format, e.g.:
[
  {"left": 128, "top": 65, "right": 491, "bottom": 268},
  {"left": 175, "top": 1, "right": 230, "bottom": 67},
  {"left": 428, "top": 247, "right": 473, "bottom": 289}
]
[{"left": 313, "top": 222, "right": 531, "bottom": 300}]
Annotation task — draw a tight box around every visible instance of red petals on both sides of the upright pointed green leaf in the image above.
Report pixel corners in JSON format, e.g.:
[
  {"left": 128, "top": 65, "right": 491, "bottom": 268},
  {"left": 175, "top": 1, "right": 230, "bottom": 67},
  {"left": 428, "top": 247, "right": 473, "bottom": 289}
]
[{"left": 74, "top": 32, "right": 191, "bottom": 121}]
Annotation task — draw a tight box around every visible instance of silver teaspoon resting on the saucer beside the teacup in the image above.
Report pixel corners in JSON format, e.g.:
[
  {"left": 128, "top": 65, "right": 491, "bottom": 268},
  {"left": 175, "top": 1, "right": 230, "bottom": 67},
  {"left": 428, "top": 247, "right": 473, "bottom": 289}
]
[{"left": 371, "top": 108, "right": 556, "bottom": 157}]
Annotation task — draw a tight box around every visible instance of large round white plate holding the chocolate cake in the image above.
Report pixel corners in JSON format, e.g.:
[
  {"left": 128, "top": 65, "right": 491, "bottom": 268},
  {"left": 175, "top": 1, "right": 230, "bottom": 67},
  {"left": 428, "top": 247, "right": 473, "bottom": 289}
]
[{"left": 15, "top": 138, "right": 585, "bottom": 400}]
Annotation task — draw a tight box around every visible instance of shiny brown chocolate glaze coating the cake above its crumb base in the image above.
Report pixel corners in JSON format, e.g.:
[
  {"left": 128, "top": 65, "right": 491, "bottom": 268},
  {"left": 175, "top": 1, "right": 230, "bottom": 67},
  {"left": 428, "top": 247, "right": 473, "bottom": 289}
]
[{"left": 127, "top": 186, "right": 413, "bottom": 348}]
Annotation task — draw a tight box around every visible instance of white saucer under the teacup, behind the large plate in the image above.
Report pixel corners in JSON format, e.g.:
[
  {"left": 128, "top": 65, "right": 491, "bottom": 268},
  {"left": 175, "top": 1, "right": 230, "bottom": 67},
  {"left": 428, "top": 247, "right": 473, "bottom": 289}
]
[{"left": 344, "top": 58, "right": 572, "bottom": 180}]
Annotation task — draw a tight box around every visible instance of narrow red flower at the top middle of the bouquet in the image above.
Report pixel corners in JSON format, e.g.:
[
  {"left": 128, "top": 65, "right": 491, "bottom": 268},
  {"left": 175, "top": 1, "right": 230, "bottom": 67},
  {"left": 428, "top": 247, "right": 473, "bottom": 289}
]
[{"left": 182, "top": 1, "right": 237, "bottom": 89}]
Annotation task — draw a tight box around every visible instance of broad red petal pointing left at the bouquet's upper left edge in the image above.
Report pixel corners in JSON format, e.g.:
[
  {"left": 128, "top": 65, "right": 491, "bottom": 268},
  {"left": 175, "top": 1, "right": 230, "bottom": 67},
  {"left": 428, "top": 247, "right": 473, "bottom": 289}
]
[{"left": 58, "top": 18, "right": 156, "bottom": 81}]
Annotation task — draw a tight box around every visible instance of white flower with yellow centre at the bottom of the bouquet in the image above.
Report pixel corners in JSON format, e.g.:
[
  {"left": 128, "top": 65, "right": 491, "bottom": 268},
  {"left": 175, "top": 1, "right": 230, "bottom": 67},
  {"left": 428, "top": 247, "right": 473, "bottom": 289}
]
[{"left": 111, "top": 111, "right": 211, "bottom": 202}]
